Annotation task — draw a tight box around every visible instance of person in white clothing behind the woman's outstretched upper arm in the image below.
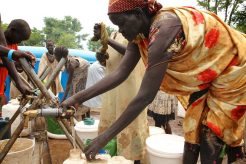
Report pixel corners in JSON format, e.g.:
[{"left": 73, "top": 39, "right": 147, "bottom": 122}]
[{"left": 84, "top": 53, "right": 109, "bottom": 113}]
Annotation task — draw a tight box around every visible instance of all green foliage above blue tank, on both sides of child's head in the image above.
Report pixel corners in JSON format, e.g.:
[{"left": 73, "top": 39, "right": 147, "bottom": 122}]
[{"left": 2, "top": 16, "right": 88, "bottom": 49}]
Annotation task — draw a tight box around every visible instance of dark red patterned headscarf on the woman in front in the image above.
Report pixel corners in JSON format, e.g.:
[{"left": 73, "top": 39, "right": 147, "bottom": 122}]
[{"left": 108, "top": 0, "right": 162, "bottom": 14}]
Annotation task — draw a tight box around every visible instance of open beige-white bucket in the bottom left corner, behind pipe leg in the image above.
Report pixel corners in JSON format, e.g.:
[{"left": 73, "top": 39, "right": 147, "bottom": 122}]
[{"left": 0, "top": 138, "right": 35, "bottom": 164}]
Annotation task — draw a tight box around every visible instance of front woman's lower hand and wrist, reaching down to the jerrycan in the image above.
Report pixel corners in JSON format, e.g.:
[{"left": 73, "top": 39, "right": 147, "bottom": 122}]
[{"left": 85, "top": 134, "right": 108, "bottom": 161}]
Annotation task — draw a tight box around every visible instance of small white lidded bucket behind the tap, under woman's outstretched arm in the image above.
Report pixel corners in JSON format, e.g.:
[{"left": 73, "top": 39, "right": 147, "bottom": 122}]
[{"left": 74, "top": 120, "right": 99, "bottom": 141}]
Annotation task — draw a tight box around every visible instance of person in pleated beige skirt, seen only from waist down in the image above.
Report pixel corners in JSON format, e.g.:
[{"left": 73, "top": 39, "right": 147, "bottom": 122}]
[{"left": 148, "top": 90, "right": 178, "bottom": 134}]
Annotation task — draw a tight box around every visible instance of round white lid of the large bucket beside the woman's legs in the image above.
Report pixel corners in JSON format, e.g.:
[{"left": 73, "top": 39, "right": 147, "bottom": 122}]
[{"left": 146, "top": 134, "right": 184, "bottom": 156}]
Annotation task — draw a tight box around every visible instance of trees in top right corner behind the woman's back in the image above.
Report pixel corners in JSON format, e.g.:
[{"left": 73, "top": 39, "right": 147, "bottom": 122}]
[{"left": 197, "top": 0, "right": 246, "bottom": 33}]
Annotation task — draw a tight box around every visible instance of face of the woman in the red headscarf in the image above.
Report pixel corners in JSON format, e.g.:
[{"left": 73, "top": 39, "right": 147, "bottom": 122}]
[{"left": 109, "top": 13, "right": 143, "bottom": 41}]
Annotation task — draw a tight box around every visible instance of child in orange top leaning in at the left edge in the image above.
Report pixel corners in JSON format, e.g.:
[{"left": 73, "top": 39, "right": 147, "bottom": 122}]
[{"left": 0, "top": 19, "right": 35, "bottom": 104}]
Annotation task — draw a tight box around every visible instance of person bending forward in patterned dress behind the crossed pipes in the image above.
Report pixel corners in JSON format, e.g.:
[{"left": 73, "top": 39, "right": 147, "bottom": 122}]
[{"left": 54, "top": 47, "right": 90, "bottom": 120}]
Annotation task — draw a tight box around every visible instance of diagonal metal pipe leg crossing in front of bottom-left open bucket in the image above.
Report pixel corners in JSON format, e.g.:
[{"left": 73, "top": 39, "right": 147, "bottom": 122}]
[{"left": 0, "top": 118, "right": 25, "bottom": 163}]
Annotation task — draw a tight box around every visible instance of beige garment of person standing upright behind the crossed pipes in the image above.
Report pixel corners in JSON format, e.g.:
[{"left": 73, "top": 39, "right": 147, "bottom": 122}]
[{"left": 38, "top": 53, "right": 63, "bottom": 95}]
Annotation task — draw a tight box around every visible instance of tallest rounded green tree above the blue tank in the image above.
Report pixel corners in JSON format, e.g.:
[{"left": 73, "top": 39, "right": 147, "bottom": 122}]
[{"left": 43, "top": 16, "right": 88, "bottom": 49}]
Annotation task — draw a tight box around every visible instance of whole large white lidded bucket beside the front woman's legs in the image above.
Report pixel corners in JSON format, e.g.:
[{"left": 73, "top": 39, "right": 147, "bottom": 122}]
[{"left": 146, "top": 134, "right": 184, "bottom": 164}]
